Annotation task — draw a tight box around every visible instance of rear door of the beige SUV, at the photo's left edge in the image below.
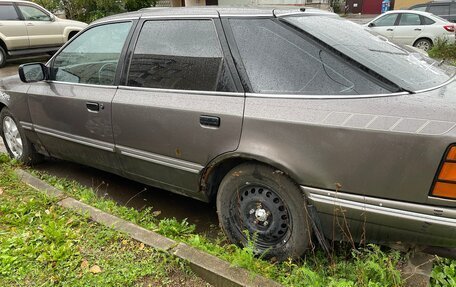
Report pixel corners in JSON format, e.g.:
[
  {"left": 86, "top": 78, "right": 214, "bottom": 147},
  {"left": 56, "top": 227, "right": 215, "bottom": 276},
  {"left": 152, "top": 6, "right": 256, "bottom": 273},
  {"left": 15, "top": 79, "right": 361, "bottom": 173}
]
[{"left": 0, "top": 2, "right": 29, "bottom": 50}]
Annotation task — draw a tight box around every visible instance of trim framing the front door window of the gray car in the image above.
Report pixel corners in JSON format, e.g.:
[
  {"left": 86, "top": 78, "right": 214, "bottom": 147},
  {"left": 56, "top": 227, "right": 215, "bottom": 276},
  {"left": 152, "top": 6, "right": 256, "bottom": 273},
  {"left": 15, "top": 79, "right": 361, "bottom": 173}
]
[{"left": 46, "top": 18, "right": 138, "bottom": 88}]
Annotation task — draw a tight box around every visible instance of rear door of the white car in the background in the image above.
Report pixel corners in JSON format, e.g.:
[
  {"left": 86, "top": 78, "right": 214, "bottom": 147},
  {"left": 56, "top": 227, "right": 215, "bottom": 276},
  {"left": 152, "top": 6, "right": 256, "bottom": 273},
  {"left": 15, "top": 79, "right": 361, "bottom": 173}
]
[{"left": 393, "top": 13, "right": 426, "bottom": 45}]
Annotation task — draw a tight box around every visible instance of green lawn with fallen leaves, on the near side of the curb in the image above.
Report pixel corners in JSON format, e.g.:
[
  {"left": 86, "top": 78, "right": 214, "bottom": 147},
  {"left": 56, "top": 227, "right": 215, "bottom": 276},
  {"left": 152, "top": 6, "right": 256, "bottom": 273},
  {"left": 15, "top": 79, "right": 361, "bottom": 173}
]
[{"left": 0, "top": 154, "right": 204, "bottom": 287}]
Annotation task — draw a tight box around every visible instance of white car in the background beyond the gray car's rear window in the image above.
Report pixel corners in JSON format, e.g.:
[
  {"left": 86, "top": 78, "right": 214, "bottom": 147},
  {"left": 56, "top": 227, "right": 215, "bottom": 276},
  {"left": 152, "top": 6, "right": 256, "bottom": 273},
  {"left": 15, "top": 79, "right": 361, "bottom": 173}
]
[{"left": 364, "top": 10, "right": 455, "bottom": 51}]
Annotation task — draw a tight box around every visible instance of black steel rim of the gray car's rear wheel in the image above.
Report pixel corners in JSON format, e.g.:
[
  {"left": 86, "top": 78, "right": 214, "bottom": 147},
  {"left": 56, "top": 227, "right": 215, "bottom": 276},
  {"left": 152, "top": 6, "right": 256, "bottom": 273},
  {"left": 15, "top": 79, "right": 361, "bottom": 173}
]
[{"left": 231, "top": 185, "right": 292, "bottom": 250}]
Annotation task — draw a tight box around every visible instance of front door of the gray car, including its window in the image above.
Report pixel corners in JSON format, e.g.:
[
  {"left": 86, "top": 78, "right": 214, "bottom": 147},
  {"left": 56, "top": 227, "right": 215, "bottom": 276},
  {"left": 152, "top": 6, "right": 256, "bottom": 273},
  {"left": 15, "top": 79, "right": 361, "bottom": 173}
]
[{"left": 28, "top": 22, "right": 132, "bottom": 173}]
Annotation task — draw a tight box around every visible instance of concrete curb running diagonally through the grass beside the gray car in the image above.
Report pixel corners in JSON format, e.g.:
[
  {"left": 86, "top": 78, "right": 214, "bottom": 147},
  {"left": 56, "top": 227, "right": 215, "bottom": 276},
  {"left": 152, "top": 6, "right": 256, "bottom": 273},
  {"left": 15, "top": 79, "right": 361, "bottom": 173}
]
[{"left": 16, "top": 169, "right": 282, "bottom": 287}]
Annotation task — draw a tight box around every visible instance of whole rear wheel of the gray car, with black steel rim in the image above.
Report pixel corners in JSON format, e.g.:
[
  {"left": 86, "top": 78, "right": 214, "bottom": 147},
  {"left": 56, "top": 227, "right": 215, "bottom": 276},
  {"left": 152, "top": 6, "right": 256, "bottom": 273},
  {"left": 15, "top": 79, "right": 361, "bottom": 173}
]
[{"left": 217, "top": 163, "right": 311, "bottom": 261}]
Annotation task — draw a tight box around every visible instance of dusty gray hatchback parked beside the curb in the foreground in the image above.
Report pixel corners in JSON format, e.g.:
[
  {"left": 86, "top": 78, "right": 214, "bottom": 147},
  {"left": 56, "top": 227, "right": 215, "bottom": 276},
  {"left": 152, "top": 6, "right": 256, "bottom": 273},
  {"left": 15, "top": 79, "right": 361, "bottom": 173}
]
[{"left": 0, "top": 8, "right": 456, "bottom": 259}]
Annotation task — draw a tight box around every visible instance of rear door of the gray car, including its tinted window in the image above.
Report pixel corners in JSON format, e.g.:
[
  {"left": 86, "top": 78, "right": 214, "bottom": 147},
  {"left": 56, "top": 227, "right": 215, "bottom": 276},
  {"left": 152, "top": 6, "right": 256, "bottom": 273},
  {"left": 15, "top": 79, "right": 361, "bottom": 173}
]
[{"left": 112, "top": 17, "right": 244, "bottom": 197}]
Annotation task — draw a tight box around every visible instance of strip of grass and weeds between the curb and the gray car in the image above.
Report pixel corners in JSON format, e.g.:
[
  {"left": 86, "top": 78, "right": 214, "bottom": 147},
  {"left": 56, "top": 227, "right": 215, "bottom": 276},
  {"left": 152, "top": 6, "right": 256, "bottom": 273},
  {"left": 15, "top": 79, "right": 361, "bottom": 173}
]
[{"left": 13, "top": 156, "right": 403, "bottom": 287}]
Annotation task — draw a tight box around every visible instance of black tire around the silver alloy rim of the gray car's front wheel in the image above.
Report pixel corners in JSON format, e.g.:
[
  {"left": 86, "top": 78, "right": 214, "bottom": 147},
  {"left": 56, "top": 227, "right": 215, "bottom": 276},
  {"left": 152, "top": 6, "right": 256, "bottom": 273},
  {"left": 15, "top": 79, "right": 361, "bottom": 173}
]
[{"left": 0, "top": 108, "right": 43, "bottom": 165}]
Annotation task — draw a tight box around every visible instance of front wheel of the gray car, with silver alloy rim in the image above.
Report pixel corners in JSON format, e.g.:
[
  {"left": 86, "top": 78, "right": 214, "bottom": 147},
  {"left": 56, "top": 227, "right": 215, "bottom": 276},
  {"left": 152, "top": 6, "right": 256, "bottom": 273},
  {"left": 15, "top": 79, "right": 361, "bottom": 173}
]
[{"left": 0, "top": 108, "right": 42, "bottom": 164}]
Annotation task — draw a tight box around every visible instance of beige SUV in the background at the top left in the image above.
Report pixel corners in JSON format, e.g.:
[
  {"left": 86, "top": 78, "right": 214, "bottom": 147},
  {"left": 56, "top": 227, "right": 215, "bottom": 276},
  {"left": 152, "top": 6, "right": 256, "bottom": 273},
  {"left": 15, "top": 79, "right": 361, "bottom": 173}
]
[{"left": 0, "top": 0, "right": 87, "bottom": 67}]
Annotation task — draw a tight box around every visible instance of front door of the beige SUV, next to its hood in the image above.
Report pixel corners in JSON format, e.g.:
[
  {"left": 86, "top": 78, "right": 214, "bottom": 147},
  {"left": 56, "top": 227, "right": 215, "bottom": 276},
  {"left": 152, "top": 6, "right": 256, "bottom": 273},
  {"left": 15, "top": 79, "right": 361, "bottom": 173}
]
[{"left": 17, "top": 3, "right": 64, "bottom": 48}]
